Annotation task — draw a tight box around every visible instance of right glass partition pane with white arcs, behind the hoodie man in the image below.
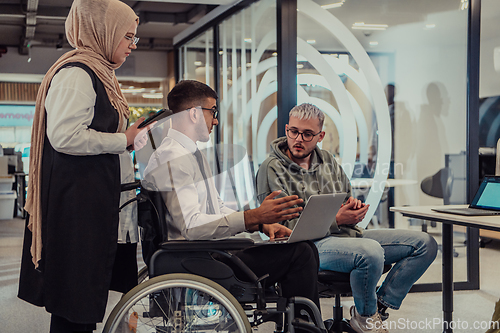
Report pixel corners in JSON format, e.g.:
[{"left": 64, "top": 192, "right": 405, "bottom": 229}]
[{"left": 297, "top": 0, "right": 468, "bottom": 282}]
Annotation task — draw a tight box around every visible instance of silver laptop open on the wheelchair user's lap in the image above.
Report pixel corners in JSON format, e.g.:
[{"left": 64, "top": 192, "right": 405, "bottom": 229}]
[{"left": 255, "top": 193, "right": 347, "bottom": 244}]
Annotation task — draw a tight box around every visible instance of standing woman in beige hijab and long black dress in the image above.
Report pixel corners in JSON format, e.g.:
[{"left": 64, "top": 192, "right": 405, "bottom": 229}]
[{"left": 19, "top": 0, "right": 144, "bottom": 333}]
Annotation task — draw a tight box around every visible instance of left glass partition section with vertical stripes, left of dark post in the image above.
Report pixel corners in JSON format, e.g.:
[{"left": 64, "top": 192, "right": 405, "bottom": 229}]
[{"left": 178, "top": 0, "right": 277, "bottom": 209}]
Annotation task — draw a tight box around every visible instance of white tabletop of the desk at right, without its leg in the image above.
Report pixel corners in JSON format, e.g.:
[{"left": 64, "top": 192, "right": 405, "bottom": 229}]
[{"left": 390, "top": 205, "right": 500, "bottom": 231}]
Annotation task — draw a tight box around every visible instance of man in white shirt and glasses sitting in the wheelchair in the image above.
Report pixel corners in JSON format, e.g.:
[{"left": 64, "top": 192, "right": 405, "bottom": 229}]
[{"left": 144, "top": 80, "right": 319, "bottom": 316}]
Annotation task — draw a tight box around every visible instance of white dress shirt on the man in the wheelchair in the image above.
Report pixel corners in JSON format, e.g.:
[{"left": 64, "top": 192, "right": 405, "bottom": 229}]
[{"left": 144, "top": 129, "right": 245, "bottom": 240}]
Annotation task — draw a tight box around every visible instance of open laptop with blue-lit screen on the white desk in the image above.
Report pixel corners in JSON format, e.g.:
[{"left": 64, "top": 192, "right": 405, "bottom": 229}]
[{"left": 432, "top": 176, "right": 500, "bottom": 216}]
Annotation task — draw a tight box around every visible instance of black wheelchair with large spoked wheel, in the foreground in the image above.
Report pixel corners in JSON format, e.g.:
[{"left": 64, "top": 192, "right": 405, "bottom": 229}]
[{"left": 103, "top": 183, "right": 327, "bottom": 333}]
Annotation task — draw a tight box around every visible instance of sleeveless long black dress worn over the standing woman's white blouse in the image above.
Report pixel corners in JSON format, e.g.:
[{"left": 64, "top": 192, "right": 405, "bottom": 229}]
[{"left": 18, "top": 63, "right": 120, "bottom": 323}]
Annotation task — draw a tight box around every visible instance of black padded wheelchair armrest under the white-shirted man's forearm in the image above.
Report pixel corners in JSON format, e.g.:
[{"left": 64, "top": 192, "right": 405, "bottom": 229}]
[{"left": 160, "top": 238, "right": 254, "bottom": 251}]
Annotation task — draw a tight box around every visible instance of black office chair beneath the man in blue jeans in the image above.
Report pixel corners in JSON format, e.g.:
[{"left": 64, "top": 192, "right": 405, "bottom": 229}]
[{"left": 318, "top": 265, "right": 392, "bottom": 333}]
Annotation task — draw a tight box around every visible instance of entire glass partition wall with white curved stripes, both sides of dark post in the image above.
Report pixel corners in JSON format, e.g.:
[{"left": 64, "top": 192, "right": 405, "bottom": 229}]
[{"left": 176, "top": 0, "right": 480, "bottom": 290}]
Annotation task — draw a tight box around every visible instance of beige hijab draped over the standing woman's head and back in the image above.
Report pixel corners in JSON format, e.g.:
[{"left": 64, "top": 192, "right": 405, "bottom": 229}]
[{"left": 24, "top": 0, "right": 139, "bottom": 267}]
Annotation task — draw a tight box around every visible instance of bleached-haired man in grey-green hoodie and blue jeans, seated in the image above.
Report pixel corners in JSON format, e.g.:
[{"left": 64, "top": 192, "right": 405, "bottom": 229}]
[{"left": 257, "top": 104, "right": 437, "bottom": 333}]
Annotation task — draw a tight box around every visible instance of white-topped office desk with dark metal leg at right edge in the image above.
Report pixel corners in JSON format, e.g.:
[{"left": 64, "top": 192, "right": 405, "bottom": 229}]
[{"left": 391, "top": 205, "right": 500, "bottom": 333}]
